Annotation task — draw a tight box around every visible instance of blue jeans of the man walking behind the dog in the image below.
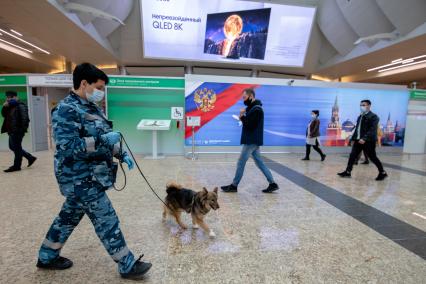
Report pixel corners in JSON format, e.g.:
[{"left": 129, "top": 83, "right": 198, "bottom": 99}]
[{"left": 232, "top": 144, "right": 274, "bottom": 186}]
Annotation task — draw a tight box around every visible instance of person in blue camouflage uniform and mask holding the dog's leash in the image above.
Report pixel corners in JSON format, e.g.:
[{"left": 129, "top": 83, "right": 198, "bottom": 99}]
[{"left": 37, "top": 63, "right": 152, "bottom": 279}]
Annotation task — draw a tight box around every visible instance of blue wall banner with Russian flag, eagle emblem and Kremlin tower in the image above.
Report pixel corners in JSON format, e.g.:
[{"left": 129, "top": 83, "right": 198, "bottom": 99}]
[{"left": 185, "top": 82, "right": 409, "bottom": 146}]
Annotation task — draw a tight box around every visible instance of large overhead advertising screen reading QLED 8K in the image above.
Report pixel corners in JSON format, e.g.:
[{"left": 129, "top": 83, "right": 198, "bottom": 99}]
[{"left": 141, "top": 0, "right": 315, "bottom": 67}]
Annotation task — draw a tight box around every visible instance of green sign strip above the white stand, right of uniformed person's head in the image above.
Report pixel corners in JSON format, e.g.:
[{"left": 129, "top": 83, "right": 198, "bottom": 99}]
[{"left": 108, "top": 76, "right": 185, "bottom": 89}]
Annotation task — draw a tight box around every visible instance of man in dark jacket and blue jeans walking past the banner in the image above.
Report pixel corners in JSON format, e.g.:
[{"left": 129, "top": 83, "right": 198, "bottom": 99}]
[{"left": 221, "top": 89, "right": 279, "bottom": 193}]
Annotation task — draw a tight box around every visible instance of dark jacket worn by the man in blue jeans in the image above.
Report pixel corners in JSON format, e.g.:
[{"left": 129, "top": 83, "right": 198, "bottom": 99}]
[{"left": 241, "top": 100, "right": 264, "bottom": 146}]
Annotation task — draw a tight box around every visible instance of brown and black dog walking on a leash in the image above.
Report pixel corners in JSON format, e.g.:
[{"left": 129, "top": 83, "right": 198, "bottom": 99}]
[{"left": 163, "top": 183, "right": 220, "bottom": 238}]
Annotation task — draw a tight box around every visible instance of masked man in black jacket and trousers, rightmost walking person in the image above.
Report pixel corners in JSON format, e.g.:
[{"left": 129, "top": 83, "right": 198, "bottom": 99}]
[{"left": 338, "top": 100, "right": 388, "bottom": 180}]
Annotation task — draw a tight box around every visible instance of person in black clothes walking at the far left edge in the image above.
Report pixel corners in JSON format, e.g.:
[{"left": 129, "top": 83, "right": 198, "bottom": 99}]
[{"left": 1, "top": 91, "right": 37, "bottom": 173}]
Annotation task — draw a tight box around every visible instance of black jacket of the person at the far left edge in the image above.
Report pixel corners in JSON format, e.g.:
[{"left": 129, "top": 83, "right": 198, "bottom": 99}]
[{"left": 1, "top": 101, "right": 30, "bottom": 135}]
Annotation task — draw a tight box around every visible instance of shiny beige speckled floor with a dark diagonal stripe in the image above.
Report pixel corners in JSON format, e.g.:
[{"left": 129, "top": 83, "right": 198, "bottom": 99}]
[{"left": 0, "top": 152, "right": 426, "bottom": 284}]
